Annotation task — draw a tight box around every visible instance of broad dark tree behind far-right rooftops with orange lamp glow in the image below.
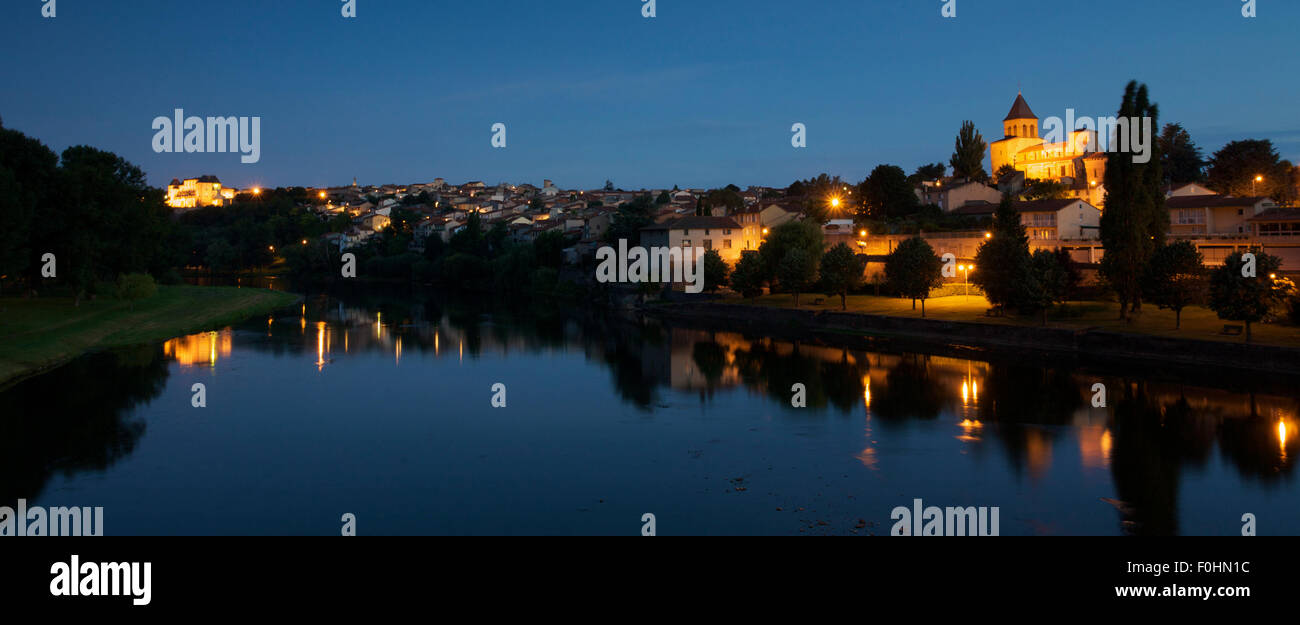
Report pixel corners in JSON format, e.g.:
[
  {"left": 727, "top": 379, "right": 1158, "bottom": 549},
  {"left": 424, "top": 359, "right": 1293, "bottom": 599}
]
[{"left": 1206, "top": 139, "right": 1295, "bottom": 202}]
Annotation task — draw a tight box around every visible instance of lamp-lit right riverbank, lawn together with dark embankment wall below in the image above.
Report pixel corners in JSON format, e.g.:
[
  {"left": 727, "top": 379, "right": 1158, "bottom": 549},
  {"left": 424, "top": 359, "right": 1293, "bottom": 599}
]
[{"left": 645, "top": 295, "right": 1300, "bottom": 373}]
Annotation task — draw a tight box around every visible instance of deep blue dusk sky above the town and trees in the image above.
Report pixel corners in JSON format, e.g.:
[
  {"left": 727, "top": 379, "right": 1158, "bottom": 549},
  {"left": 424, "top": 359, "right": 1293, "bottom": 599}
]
[{"left": 0, "top": 0, "right": 1300, "bottom": 188}]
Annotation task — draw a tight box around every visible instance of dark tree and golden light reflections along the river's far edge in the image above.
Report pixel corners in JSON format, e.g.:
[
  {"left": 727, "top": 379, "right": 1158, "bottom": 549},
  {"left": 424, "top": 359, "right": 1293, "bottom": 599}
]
[{"left": 0, "top": 284, "right": 1300, "bottom": 534}]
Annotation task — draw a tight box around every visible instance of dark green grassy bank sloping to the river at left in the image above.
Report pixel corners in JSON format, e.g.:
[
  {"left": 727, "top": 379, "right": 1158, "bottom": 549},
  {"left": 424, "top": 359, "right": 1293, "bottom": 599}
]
[{"left": 0, "top": 286, "right": 298, "bottom": 386}]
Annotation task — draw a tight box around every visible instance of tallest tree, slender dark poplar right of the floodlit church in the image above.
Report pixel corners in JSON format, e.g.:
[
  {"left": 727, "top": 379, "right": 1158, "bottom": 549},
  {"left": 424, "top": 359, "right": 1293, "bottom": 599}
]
[{"left": 1100, "top": 81, "right": 1169, "bottom": 320}]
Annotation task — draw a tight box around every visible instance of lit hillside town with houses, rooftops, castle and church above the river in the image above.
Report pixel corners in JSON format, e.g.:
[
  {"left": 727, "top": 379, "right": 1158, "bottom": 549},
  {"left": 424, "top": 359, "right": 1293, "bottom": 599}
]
[{"left": 168, "top": 95, "right": 1300, "bottom": 272}]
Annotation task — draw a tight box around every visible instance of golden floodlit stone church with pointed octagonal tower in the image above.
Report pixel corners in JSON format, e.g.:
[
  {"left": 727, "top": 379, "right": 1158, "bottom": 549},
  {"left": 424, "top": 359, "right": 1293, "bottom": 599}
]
[{"left": 989, "top": 95, "right": 1106, "bottom": 208}]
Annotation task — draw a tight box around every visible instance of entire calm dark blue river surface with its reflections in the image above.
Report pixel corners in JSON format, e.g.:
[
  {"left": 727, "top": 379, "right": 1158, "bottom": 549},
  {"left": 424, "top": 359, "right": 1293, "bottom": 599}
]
[{"left": 0, "top": 284, "right": 1300, "bottom": 535}]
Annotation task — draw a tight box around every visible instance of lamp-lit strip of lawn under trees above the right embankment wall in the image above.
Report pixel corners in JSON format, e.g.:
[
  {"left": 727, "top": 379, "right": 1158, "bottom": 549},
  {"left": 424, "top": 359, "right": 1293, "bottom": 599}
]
[{"left": 724, "top": 294, "right": 1300, "bottom": 348}]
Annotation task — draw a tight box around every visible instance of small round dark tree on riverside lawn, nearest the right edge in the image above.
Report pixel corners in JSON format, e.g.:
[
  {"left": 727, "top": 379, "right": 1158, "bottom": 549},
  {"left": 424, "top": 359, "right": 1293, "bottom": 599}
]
[{"left": 1209, "top": 249, "right": 1284, "bottom": 343}]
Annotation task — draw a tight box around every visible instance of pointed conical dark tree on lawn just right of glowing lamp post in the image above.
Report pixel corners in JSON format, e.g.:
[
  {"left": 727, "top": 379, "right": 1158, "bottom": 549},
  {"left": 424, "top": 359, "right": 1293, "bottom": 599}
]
[{"left": 971, "top": 196, "right": 1030, "bottom": 312}]
